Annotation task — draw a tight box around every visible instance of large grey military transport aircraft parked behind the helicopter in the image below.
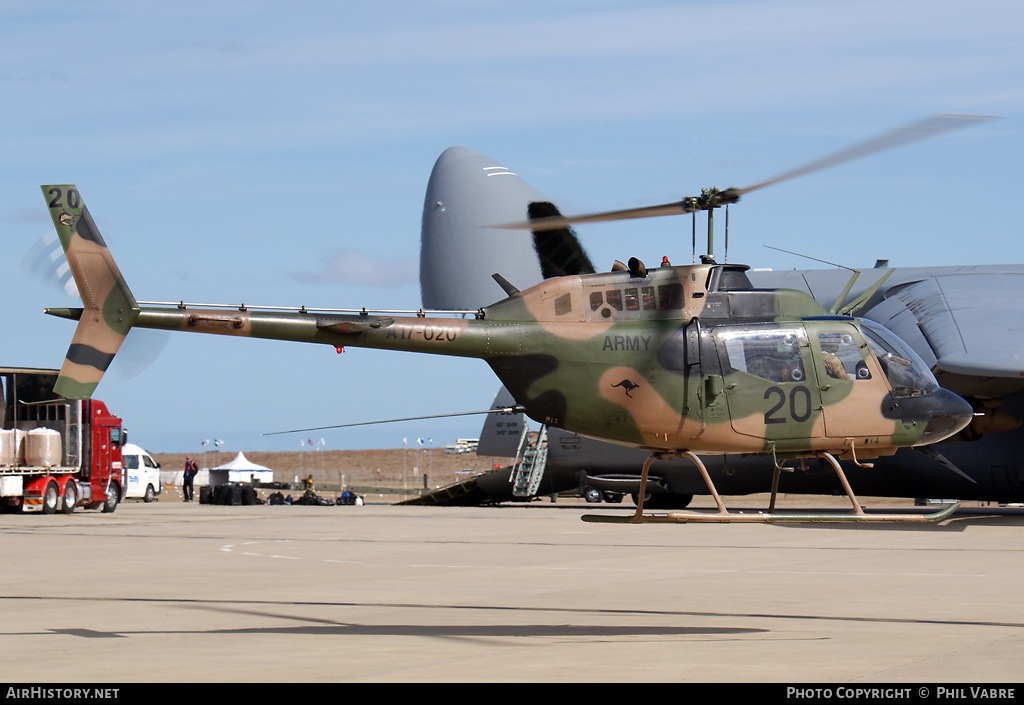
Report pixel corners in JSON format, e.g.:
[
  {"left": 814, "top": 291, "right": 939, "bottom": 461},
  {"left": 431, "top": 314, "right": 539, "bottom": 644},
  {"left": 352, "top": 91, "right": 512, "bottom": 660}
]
[{"left": 421, "top": 120, "right": 1024, "bottom": 508}]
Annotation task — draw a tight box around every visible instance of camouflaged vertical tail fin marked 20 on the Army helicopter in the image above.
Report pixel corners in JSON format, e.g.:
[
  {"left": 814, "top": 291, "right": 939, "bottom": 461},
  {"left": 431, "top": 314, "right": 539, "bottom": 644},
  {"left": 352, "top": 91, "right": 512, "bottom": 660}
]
[{"left": 42, "top": 184, "right": 138, "bottom": 399}]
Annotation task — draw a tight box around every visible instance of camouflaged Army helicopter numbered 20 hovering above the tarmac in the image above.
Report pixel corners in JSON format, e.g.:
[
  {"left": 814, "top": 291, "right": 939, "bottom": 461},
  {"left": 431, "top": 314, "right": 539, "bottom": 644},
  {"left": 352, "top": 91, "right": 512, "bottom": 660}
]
[{"left": 41, "top": 141, "right": 973, "bottom": 523}]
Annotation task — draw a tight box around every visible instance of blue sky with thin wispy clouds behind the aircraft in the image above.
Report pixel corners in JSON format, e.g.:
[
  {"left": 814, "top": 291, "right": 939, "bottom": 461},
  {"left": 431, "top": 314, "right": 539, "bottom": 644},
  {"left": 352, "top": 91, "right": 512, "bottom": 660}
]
[{"left": 0, "top": 0, "right": 1024, "bottom": 452}]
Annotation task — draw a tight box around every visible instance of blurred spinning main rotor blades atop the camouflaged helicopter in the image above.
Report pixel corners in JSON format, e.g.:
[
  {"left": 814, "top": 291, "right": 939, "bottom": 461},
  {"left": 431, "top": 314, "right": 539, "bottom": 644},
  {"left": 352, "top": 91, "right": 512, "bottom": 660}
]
[{"left": 507, "top": 115, "right": 992, "bottom": 231}]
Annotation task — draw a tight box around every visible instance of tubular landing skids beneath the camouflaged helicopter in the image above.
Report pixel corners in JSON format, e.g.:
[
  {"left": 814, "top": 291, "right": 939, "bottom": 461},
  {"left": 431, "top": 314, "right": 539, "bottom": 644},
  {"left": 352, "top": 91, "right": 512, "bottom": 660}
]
[{"left": 582, "top": 451, "right": 959, "bottom": 524}]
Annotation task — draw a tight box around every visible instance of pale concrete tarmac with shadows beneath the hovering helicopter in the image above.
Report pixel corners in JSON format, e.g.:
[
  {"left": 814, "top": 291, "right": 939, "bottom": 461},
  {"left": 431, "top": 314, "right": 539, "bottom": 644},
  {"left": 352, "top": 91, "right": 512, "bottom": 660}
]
[{"left": 0, "top": 498, "right": 1024, "bottom": 692}]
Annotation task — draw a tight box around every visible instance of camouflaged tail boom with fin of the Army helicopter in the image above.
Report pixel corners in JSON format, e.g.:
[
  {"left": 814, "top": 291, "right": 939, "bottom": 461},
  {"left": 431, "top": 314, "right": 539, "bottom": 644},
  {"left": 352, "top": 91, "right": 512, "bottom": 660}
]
[{"left": 42, "top": 184, "right": 503, "bottom": 399}]
